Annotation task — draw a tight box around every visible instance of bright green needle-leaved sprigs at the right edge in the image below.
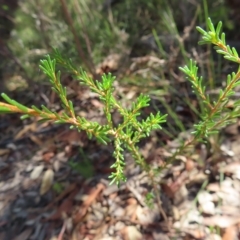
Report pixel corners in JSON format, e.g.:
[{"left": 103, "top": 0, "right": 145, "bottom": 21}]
[{"left": 180, "top": 18, "right": 240, "bottom": 140}]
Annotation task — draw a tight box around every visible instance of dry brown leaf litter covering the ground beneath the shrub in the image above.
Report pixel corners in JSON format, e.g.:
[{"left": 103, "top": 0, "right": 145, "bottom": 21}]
[{"left": 0, "top": 47, "right": 240, "bottom": 240}]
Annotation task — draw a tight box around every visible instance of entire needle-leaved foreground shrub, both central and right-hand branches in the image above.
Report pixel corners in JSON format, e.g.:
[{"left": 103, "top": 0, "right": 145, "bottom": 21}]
[{"left": 0, "top": 19, "right": 240, "bottom": 188}]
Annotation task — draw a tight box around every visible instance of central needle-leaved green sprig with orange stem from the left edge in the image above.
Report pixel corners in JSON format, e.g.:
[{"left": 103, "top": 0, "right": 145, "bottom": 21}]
[{"left": 0, "top": 50, "right": 166, "bottom": 184}]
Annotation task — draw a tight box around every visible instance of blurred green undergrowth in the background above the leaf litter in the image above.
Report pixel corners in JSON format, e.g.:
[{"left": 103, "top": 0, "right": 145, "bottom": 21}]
[{"left": 3, "top": 0, "right": 229, "bottom": 85}]
